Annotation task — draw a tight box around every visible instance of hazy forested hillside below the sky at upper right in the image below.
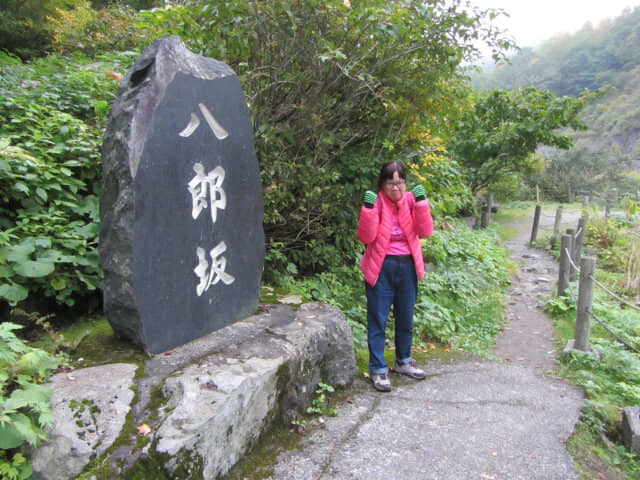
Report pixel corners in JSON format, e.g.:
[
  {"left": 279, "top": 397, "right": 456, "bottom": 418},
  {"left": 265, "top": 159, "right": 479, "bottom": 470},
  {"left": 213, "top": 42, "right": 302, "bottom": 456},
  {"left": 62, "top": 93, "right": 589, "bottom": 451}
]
[{"left": 473, "top": 7, "right": 640, "bottom": 188}]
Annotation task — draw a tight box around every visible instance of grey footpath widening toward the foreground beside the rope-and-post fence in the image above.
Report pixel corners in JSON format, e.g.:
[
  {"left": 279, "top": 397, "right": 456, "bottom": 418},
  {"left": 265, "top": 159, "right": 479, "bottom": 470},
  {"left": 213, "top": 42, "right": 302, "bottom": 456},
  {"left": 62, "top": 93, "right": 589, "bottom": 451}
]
[{"left": 258, "top": 211, "right": 583, "bottom": 480}]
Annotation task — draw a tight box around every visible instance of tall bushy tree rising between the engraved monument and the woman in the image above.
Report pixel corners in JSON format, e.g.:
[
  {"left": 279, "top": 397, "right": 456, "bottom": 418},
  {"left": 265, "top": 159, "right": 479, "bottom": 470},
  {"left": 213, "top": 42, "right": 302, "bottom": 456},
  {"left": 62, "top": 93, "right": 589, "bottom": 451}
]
[{"left": 192, "top": 0, "right": 508, "bottom": 269}]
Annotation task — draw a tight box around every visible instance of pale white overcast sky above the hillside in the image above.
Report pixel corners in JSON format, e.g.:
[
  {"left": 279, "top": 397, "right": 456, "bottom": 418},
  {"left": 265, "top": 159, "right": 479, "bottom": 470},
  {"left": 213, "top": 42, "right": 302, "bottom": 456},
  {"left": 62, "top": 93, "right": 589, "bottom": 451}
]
[{"left": 470, "top": 0, "right": 640, "bottom": 47}]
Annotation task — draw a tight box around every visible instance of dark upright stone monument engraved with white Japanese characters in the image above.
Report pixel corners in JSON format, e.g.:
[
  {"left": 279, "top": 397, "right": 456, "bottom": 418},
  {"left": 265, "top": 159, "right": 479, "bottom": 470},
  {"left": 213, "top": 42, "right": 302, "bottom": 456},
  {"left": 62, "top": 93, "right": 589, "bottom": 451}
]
[{"left": 100, "top": 36, "right": 264, "bottom": 353}]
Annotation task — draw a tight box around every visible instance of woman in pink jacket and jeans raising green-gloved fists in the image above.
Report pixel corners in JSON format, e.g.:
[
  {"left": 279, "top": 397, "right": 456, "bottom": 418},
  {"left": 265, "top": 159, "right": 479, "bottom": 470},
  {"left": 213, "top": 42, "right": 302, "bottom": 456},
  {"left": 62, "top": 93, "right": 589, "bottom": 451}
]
[{"left": 358, "top": 162, "right": 433, "bottom": 392}]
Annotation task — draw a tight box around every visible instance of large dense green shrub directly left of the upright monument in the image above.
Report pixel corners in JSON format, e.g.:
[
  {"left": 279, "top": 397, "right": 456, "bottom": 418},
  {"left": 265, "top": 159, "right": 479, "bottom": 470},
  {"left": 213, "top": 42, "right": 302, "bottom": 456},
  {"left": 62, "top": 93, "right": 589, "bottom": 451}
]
[{"left": 0, "top": 55, "right": 130, "bottom": 305}]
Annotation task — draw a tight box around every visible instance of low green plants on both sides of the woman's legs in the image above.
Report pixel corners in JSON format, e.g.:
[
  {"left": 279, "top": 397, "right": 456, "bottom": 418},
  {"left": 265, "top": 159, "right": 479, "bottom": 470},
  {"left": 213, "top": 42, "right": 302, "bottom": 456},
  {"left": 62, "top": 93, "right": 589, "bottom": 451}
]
[{"left": 282, "top": 222, "right": 509, "bottom": 354}]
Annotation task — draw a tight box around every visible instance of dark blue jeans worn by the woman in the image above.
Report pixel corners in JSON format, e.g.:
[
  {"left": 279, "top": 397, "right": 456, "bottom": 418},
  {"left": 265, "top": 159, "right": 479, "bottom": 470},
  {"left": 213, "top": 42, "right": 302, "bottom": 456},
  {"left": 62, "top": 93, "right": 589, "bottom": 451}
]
[{"left": 365, "top": 257, "right": 418, "bottom": 374}]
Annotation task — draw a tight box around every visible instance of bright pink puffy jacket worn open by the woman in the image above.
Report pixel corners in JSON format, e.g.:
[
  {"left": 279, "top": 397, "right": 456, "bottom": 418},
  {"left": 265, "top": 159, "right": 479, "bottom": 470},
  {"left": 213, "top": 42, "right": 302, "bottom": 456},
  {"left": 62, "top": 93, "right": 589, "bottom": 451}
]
[{"left": 358, "top": 192, "right": 433, "bottom": 286}]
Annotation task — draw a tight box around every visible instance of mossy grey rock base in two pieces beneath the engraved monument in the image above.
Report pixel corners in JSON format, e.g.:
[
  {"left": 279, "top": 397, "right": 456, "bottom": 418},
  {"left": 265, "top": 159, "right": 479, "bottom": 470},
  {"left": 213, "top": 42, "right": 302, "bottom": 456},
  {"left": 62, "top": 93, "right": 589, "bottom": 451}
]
[{"left": 32, "top": 303, "right": 356, "bottom": 480}]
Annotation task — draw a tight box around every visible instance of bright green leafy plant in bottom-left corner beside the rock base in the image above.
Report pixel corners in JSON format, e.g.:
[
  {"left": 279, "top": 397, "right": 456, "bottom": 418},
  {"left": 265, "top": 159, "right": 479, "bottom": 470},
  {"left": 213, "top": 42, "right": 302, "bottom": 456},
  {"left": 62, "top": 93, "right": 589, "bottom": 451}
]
[{"left": 0, "top": 322, "right": 59, "bottom": 480}]
